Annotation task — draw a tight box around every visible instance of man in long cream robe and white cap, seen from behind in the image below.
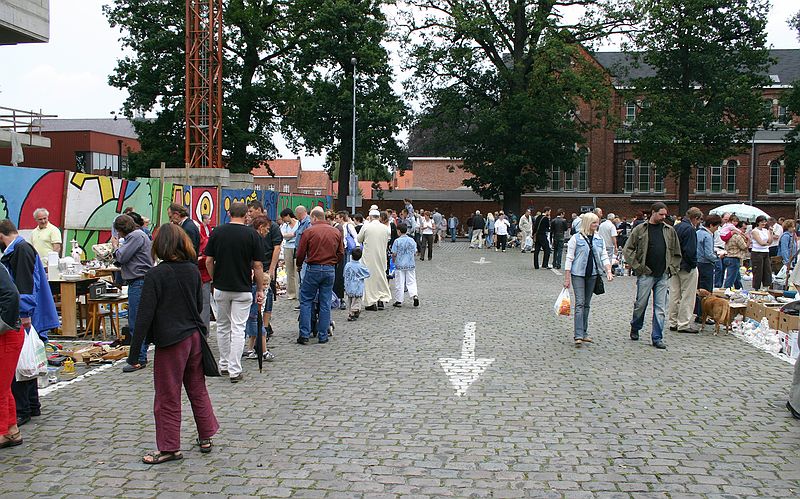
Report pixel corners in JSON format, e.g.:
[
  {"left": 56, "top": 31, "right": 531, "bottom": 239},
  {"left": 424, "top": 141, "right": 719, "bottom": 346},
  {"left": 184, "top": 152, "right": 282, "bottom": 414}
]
[{"left": 358, "top": 210, "right": 392, "bottom": 311}]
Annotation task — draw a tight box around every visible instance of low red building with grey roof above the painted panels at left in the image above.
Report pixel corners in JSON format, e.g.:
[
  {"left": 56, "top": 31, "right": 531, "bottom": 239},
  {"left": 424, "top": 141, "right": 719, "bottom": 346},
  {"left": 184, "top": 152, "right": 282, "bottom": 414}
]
[{"left": 0, "top": 118, "right": 141, "bottom": 177}]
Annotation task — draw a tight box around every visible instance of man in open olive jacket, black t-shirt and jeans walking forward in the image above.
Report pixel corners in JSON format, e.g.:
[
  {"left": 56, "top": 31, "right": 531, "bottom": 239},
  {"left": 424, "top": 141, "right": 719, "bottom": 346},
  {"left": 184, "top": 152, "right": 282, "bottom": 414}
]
[{"left": 623, "top": 202, "right": 681, "bottom": 350}]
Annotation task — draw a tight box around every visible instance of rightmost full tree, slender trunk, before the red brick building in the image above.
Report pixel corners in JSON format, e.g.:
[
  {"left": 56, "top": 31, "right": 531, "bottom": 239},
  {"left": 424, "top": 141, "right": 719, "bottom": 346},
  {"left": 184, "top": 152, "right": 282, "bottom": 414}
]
[{"left": 629, "top": 0, "right": 770, "bottom": 213}]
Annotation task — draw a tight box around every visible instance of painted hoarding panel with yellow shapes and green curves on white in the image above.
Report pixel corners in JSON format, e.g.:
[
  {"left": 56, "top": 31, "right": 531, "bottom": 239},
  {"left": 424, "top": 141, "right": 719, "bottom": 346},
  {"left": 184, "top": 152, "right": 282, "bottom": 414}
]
[{"left": 64, "top": 173, "right": 159, "bottom": 230}]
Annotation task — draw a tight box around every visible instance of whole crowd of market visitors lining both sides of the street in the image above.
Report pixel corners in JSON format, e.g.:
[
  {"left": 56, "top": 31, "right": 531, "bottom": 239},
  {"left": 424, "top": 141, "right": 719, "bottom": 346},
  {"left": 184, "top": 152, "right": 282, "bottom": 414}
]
[{"left": 0, "top": 195, "right": 800, "bottom": 464}]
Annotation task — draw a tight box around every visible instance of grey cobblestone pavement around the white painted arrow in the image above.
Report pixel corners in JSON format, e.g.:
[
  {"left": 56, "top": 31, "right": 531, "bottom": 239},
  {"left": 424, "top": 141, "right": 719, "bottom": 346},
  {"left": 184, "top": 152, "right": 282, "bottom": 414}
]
[{"left": 0, "top": 242, "right": 800, "bottom": 498}]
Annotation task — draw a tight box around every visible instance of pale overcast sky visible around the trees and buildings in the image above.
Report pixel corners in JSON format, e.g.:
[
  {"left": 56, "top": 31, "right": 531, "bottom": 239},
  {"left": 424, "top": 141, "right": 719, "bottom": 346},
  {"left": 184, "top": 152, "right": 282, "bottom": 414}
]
[{"left": 0, "top": 0, "right": 800, "bottom": 168}]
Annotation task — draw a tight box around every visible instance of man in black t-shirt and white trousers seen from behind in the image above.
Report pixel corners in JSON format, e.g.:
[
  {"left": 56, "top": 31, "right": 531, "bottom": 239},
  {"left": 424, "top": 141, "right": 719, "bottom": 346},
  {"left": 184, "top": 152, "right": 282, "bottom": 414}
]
[{"left": 206, "top": 203, "right": 270, "bottom": 383}]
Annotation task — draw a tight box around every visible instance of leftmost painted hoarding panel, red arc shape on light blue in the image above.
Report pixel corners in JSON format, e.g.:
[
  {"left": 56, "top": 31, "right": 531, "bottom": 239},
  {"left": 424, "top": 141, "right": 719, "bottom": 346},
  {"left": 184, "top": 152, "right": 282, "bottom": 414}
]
[{"left": 0, "top": 166, "right": 65, "bottom": 230}]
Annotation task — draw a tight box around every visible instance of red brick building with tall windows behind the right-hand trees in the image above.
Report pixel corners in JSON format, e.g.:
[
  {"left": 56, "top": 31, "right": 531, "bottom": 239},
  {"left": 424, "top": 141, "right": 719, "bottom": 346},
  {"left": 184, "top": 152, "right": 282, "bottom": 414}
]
[{"left": 404, "top": 49, "right": 800, "bottom": 220}]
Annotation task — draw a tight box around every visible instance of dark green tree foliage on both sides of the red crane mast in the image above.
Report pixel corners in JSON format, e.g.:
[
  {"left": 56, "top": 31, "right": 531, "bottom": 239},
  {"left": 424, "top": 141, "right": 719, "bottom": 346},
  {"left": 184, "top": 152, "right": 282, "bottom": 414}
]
[{"left": 104, "top": 0, "right": 404, "bottom": 189}]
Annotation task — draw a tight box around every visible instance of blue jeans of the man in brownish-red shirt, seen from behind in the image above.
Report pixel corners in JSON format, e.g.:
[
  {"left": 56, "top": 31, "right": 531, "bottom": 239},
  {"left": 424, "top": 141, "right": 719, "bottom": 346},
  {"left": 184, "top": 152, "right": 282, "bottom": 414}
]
[{"left": 300, "top": 264, "right": 336, "bottom": 342}]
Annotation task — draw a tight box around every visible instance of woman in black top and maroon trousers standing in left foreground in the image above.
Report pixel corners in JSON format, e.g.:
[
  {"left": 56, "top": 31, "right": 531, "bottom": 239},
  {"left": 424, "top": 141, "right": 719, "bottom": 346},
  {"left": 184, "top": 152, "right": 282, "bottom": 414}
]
[{"left": 128, "top": 224, "right": 219, "bottom": 464}]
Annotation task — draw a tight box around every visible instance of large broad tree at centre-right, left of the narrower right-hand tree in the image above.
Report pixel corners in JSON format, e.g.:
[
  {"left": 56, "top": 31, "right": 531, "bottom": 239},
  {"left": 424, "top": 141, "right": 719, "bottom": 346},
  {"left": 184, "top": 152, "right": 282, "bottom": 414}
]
[{"left": 406, "top": 0, "right": 624, "bottom": 212}]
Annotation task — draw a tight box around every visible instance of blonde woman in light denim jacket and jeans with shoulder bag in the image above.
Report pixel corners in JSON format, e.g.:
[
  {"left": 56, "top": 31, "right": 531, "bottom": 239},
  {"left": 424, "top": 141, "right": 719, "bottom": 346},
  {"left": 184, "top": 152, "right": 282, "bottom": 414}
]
[{"left": 564, "top": 213, "right": 614, "bottom": 348}]
